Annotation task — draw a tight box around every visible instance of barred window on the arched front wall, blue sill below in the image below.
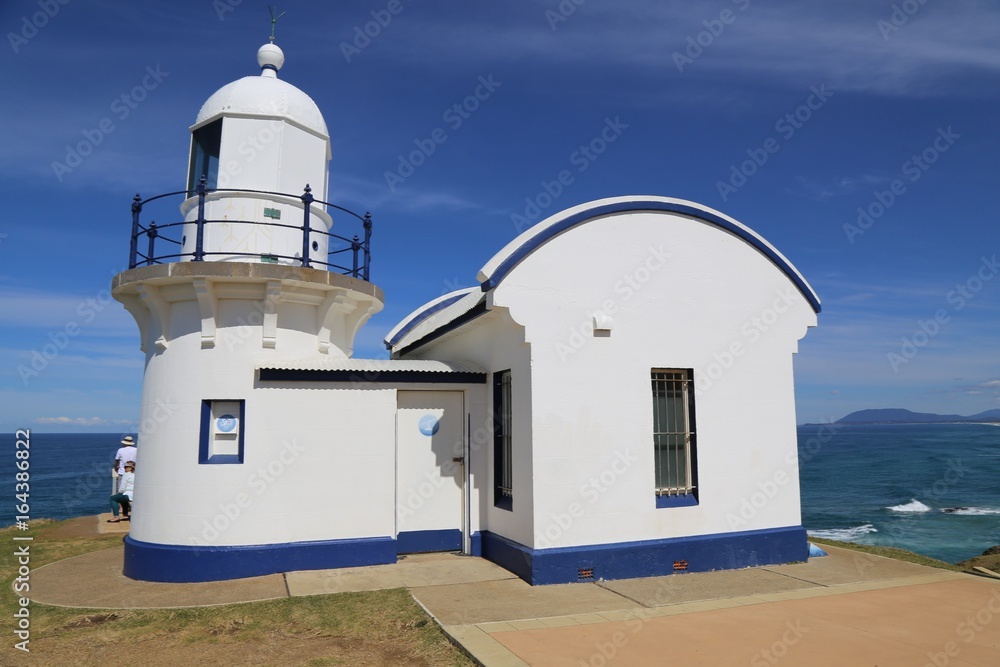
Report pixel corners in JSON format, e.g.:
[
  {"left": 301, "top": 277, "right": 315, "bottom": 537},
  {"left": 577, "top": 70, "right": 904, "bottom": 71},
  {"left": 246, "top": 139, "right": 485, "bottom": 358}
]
[{"left": 651, "top": 368, "right": 697, "bottom": 507}]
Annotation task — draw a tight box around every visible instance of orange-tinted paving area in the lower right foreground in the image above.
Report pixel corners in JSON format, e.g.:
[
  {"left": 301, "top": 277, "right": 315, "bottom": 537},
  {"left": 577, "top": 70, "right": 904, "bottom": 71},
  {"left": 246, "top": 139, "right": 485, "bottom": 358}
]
[{"left": 490, "top": 578, "right": 1000, "bottom": 667}]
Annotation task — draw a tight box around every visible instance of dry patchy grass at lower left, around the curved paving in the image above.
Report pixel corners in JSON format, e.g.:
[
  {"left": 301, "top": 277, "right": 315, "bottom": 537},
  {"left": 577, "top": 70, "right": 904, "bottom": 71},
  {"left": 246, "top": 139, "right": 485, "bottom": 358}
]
[{"left": 0, "top": 522, "right": 473, "bottom": 667}]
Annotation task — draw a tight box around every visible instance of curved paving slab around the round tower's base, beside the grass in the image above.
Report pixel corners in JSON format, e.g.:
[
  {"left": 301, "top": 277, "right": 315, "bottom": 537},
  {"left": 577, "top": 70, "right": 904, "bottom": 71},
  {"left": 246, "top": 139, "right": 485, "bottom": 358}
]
[{"left": 31, "top": 547, "right": 288, "bottom": 609}]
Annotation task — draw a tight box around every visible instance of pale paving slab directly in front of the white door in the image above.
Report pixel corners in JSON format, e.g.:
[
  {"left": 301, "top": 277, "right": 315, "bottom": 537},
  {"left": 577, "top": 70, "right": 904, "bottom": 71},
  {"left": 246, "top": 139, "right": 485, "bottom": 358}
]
[{"left": 286, "top": 553, "right": 516, "bottom": 595}]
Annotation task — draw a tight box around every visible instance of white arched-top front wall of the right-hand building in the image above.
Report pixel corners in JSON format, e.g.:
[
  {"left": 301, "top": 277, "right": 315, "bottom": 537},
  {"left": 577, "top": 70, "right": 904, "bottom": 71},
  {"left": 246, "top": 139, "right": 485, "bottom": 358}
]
[{"left": 418, "top": 212, "right": 816, "bottom": 548}]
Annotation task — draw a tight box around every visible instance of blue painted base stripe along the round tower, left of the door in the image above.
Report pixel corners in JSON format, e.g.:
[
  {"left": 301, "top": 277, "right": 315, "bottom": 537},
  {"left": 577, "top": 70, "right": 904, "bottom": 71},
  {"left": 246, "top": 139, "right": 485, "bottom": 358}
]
[{"left": 128, "top": 536, "right": 396, "bottom": 582}]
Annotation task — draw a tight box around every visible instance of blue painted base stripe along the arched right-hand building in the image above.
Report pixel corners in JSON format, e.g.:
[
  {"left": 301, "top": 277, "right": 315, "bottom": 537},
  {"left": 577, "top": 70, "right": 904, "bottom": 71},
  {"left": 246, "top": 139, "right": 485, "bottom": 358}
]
[{"left": 483, "top": 526, "right": 809, "bottom": 585}]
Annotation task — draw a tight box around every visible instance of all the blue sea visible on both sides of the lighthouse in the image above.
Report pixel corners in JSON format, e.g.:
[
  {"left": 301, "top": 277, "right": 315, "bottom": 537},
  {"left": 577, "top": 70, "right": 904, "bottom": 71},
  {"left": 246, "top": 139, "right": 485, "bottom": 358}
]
[{"left": 0, "top": 424, "right": 1000, "bottom": 563}]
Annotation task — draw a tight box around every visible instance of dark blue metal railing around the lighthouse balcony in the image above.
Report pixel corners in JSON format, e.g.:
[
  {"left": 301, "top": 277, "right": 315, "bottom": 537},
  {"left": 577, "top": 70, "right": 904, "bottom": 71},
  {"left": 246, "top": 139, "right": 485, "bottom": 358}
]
[{"left": 128, "top": 178, "right": 372, "bottom": 281}]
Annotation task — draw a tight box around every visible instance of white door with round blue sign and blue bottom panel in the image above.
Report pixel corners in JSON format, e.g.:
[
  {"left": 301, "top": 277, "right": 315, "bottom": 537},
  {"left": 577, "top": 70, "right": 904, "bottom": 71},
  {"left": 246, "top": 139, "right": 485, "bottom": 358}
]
[{"left": 396, "top": 391, "right": 465, "bottom": 553}]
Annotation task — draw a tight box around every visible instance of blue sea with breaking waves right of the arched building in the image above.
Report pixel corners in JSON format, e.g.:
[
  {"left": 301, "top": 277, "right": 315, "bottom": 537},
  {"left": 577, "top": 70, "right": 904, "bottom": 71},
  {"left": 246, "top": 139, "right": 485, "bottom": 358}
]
[{"left": 798, "top": 424, "right": 1000, "bottom": 563}]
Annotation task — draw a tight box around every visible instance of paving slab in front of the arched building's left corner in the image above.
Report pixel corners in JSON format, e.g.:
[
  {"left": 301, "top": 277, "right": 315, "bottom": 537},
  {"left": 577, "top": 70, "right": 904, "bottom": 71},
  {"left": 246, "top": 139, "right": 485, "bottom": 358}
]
[{"left": 410, "top": 578, "right": 636, "bottom": 625}]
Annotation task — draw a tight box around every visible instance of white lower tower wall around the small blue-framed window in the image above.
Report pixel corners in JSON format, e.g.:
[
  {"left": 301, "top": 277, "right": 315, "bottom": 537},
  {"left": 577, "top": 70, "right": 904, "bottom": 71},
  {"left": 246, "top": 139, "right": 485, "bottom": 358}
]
[{"left": 132, "top": 326, "right": 396, "bottom": 545}]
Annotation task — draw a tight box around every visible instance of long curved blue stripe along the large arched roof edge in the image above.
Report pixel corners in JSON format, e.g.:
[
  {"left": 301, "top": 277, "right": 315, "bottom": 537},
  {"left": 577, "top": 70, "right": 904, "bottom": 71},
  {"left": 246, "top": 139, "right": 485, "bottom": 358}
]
[{"left": 480, "top": 199, "right": 822, "bottom": 313}]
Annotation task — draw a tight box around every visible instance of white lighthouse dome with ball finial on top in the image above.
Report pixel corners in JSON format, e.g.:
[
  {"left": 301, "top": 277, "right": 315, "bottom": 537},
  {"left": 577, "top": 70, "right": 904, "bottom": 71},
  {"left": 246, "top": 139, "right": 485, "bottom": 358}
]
[{"left": 195, "top": 44, "right": 329, "bottom": 138}]
